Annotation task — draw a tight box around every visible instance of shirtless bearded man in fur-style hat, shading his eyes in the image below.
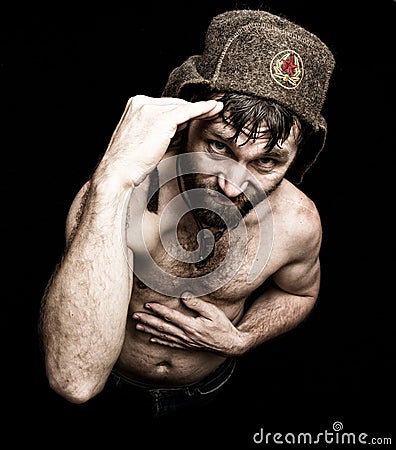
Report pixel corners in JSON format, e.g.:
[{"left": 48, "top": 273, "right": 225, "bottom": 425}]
[{"left": 40, "top": 10, "right": 334, "bottom": 415}]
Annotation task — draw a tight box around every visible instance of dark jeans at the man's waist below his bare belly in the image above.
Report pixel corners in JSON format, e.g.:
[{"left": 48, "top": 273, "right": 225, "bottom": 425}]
[{"left": 108, "top": 358, "right": 236, "bottom": 417}]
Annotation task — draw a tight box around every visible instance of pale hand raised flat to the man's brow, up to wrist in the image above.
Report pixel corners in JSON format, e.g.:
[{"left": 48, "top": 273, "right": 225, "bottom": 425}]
[{"left": 96, "top": 95, "right": 223, "bottom": 188}]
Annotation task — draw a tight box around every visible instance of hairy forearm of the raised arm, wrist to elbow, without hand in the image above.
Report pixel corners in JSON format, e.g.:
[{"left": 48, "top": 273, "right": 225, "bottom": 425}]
[{"left": 40, "top": 176, "right": 132, "bottom": 403}]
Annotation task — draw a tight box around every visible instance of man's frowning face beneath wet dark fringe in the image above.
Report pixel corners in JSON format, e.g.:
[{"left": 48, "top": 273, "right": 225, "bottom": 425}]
[{"left": 183, "top": 116, "right": 298, "bottom": 228}]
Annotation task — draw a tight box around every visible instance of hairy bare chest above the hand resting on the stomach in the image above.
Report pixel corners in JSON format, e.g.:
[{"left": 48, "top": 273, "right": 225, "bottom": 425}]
[{"left": 134, "top": 216, "right": 273, "bottom": 301}]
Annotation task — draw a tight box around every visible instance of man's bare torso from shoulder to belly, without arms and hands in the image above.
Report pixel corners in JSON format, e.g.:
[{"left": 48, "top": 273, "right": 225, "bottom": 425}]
[{"left": 116, "top": 167, "right": 316, "bottom": 386}]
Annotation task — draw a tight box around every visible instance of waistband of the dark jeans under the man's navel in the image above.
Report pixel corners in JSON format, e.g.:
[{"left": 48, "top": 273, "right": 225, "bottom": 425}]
[{"left": 110, "top": 357, "right": 236, "bottom": 391}]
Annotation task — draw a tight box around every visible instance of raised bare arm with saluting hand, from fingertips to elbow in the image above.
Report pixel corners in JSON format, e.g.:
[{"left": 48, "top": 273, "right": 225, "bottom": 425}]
[{"left": 39, "top": 96, "right": 222, "bottom": 403}]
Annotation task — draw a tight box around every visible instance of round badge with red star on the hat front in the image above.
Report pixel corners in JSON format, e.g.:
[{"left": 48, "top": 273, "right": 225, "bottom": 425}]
[{"left": 270, "top": 50, "right": 304, "bottom": 89}]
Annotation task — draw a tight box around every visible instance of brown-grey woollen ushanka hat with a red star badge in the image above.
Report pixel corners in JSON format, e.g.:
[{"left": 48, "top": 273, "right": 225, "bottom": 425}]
[{"left": 162, "top": 10, "right": 335, "bottom": 183}]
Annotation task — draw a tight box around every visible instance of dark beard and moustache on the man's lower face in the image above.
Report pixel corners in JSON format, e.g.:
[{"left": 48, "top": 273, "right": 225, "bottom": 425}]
[{"left": 182, "top": 173, "right": 275, "bottom": 229}]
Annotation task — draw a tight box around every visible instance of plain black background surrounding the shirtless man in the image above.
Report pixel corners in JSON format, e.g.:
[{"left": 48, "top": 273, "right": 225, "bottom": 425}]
[{"left": 0, "top": 0, "right": 396, "bottom": 449}]
